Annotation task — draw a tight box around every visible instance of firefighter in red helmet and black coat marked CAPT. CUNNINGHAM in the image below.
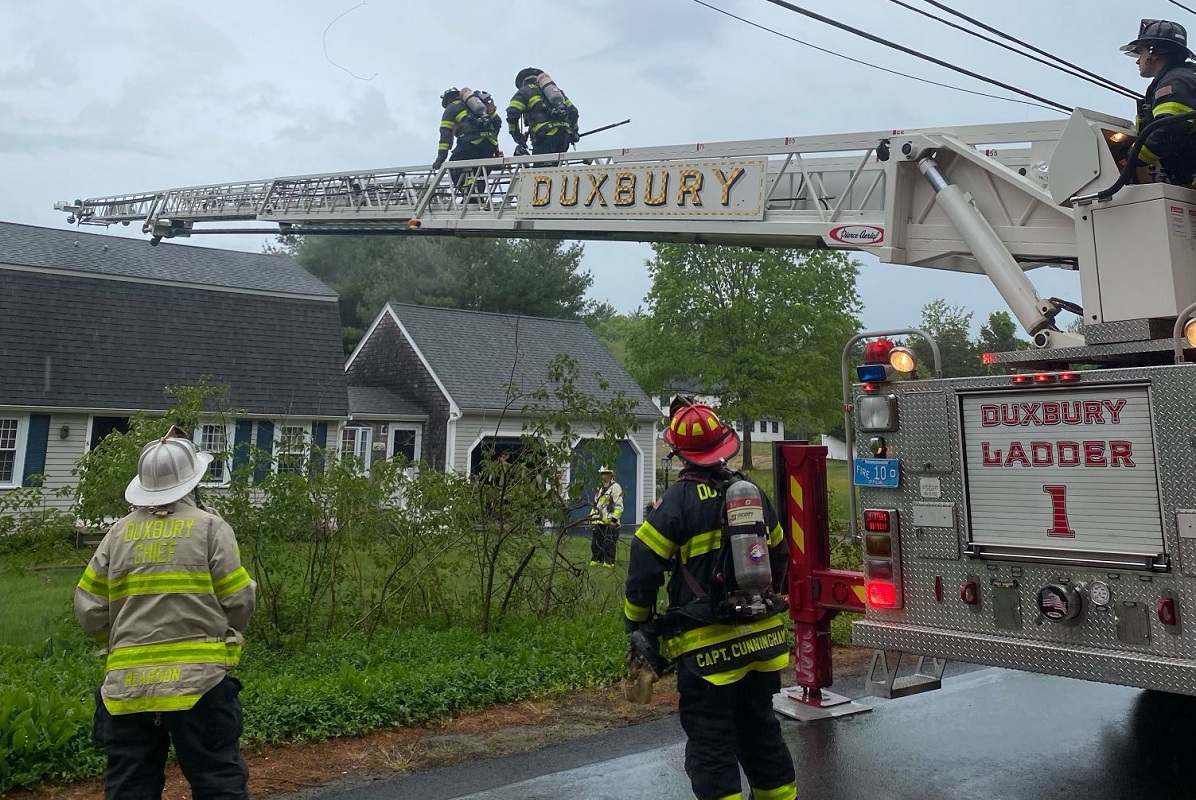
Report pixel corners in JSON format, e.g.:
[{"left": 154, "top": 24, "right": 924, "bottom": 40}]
[{"left": 624, "top": 398, "right": 798, "bottom": 800}]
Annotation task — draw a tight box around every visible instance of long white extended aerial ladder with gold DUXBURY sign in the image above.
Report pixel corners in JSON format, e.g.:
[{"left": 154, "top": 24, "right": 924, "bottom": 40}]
[{"left": 57, "top": 110, "right": 1148, "bottom": 343}]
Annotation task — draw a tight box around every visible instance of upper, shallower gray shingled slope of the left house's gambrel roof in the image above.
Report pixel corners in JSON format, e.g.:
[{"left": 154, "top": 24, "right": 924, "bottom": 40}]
[{"left": 0, "top": 222, "right": 336, "bottom": 298}]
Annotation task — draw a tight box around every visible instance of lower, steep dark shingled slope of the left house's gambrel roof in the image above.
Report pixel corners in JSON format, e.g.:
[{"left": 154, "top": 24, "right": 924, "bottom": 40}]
[{"left": 0, "top": 255, "right": 348, "bottom": 417}]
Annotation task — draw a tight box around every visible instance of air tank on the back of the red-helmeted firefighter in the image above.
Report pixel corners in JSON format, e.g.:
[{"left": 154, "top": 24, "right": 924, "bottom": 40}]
[{"left": 722, "top": 480, "right": 776, "bottom": 619}]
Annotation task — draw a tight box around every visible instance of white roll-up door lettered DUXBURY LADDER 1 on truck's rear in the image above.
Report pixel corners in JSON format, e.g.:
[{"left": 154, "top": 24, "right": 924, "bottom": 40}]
[{"left": 959, "top": 385, "right": 1165, "bottom": 558}]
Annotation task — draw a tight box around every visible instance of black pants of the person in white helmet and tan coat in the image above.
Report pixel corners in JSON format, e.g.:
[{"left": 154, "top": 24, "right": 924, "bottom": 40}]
[{"left": 92, "top": 676, "right": 249, "bottom": 800}]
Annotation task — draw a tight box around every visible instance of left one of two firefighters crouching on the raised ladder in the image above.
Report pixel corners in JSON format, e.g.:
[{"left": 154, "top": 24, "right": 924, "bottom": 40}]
[{"left": 432, "top": 87, "right": 502, "bottom": 199}]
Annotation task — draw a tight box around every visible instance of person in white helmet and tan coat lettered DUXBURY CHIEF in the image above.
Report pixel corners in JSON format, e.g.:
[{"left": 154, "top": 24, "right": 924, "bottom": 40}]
[{"left": 74, "top": 429, "right": 256, "bottom": 800}]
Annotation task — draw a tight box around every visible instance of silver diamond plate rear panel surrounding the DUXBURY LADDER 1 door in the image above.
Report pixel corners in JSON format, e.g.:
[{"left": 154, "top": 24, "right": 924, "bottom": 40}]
[{"left": 855, "top": 365, "right": 1196, "bottom": 679}]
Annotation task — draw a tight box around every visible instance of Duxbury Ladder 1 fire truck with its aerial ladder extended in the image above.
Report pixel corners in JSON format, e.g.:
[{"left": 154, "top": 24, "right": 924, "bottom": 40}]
[{"left": 57, "top": 109, "right": 1196, "bottom": 698}]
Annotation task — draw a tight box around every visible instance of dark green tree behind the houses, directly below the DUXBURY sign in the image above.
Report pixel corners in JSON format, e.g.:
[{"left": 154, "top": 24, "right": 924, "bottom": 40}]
[{"left": 279, "top": 236, "right": 593, "bottom": 352}]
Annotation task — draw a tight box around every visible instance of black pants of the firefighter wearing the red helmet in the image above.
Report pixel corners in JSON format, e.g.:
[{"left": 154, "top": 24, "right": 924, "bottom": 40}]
[{"left": 677, "top": 662, "right": 795, "bottom": 800}]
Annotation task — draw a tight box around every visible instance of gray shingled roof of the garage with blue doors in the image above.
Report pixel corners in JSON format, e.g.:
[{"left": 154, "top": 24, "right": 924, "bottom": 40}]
[{"left": 390, "top": 303, "right": 660, "bottom": 417}]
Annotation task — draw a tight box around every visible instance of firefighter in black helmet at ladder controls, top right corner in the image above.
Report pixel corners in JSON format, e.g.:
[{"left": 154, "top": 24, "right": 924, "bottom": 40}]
[{"left": 1122, "top": 19, "right": 1196, "bottom": 187}]
